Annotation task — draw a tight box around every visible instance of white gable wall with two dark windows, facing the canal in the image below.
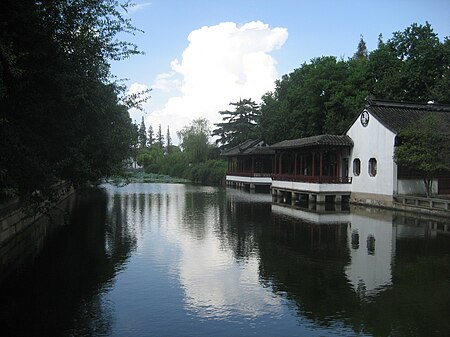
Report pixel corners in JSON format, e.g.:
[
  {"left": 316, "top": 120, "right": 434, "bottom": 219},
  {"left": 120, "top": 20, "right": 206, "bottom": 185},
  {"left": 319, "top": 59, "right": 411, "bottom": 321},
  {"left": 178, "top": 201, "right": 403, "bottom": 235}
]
[{"left": 347, "top": 112, "right": 397, "bottom": 204}]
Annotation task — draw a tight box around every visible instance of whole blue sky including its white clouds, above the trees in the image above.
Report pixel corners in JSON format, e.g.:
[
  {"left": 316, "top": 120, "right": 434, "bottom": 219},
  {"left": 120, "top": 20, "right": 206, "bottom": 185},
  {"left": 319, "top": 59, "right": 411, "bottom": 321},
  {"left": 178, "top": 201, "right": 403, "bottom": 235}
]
[{"left": 111, "top": 0, "right": 450, "bottom": 144}]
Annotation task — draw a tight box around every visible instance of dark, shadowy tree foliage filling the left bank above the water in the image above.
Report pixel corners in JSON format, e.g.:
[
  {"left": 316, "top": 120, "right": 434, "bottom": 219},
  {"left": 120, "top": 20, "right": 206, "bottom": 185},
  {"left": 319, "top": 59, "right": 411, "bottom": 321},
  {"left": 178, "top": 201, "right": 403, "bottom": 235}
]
[{"left": 0, "top": 0, "right": 143, "bottom": 201}]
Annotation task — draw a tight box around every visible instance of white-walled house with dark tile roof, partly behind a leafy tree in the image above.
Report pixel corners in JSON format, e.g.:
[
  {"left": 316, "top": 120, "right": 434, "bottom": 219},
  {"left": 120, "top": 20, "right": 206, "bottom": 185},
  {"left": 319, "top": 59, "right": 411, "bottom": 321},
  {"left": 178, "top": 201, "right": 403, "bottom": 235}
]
[{"left": 346, "top": 100, "right": 450, "bottom": 206}]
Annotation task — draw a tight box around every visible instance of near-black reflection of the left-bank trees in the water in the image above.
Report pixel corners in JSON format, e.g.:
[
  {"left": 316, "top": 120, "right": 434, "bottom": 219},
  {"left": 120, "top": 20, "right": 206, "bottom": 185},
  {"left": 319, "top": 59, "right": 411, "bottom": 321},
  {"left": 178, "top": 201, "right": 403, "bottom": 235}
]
[{"left": 0, "top": 186, "right": 134, "bottom": 336}]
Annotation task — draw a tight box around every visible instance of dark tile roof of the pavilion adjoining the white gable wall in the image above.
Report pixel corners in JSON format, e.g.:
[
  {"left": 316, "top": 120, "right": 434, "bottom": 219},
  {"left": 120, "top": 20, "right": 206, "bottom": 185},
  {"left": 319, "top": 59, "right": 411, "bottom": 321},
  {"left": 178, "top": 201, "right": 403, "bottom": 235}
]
[{"left": 270, "top": 135, "right": 353, "bottom": 149}]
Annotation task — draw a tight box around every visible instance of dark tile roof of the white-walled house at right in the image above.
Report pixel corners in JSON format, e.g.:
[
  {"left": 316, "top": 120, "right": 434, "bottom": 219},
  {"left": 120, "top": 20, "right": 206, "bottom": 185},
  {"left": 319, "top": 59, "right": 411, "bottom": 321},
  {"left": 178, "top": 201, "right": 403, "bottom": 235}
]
[{"left": 365, "top": 100, "right": 450, "bottom": 134}]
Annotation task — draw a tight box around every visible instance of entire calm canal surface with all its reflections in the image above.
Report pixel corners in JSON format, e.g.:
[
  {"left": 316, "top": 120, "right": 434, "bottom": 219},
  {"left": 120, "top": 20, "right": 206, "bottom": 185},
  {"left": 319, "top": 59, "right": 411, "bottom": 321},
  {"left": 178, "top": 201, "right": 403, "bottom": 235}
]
[{"left": 0, "top": 184, "right": 450, "bottom": 336}]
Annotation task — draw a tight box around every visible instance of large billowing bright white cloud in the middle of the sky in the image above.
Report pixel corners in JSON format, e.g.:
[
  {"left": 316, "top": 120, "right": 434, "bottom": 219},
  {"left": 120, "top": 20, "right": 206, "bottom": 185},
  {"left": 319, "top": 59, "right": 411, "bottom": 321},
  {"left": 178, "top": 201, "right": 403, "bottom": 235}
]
[{"left": 146, "top": 21, "right": 288, "bottom": 143}]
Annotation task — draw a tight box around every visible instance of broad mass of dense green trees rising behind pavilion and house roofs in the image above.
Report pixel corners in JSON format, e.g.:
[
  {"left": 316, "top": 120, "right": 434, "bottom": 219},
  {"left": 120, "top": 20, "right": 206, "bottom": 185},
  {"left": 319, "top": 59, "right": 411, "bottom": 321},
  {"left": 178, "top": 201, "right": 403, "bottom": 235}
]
[{"left": 257, "top": 23, "right": 450, "bottom": 144}]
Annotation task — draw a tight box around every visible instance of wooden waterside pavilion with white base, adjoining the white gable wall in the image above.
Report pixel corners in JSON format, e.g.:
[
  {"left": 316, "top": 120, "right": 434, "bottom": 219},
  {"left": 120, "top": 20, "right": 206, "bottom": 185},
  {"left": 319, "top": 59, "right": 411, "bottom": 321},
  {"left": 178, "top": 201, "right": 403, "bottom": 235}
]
[{"left": 271, "top": 135, "right": 353, "bottom": 204}]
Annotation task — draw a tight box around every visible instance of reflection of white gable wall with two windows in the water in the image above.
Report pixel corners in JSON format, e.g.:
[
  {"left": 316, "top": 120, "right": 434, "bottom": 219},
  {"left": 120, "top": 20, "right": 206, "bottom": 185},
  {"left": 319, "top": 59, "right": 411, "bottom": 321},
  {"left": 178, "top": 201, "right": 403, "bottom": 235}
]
[{"left": 345, "top": 208, "right": 396, "bottom": 296}]
